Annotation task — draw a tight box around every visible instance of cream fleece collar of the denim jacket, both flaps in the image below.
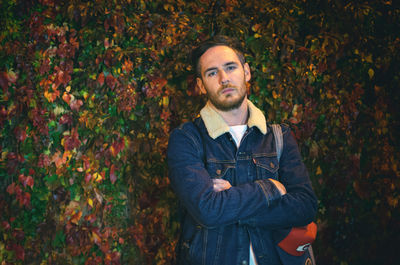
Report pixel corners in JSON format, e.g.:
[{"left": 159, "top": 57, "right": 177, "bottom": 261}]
[{"left": 200, "top": 97, "right": 267, "bottom": 139}]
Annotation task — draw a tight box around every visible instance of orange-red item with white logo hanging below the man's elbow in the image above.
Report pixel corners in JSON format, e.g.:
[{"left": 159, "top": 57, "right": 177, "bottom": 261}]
[{"left": 278, "top": 222, "right": 317, "bottom": 256}]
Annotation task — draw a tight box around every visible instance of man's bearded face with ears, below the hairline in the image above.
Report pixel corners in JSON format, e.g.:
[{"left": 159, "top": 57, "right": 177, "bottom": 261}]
[{"left": 197, "top": 46, "right": 251, "bottom": 111}]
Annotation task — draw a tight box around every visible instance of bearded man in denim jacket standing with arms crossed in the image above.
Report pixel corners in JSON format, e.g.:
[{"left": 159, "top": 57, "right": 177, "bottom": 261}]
[{"left": 167, "top": 36, "right": 317, "bottom": 265}]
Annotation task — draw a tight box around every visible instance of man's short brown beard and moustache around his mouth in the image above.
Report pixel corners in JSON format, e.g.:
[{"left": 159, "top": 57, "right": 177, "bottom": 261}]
[{"left": 208, "top": 84, "right": 246, "bottom": 112}]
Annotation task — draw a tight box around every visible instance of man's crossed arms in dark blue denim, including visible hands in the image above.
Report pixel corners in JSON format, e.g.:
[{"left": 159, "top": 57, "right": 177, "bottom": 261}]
[{"left": 168, "top": 124, "right": 316, "bottom": 229}]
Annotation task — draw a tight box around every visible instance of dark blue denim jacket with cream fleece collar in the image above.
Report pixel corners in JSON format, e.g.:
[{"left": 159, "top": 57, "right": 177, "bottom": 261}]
[{"left": 167, "top": 101, "right": 317, "bottom": 265}]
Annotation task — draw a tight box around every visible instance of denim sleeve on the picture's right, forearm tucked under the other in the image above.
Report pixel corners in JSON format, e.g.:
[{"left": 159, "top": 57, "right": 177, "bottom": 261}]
[{"left": 241, "top": 127, "right": 317, "bottom": 229}]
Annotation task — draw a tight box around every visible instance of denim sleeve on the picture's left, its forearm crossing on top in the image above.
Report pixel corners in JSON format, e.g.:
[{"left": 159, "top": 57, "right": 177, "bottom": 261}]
[{"left": 167, "top": 127, "right": 282, "bottom": 228}]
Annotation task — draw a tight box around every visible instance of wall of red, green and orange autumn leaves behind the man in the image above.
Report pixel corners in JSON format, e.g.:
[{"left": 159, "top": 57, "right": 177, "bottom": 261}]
[{"left": 0, "top": 0, "right": 400, "bottom": 265}]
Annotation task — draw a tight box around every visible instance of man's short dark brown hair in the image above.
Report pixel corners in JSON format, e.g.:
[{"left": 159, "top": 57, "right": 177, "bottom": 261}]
[{"left": 191, "top": 35, "right": 245, "bottom": 77}]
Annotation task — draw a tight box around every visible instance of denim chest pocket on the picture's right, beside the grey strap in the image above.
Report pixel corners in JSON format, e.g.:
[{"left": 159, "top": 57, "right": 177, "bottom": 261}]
[{"left": 253, "top": 155, "right": 279, "bottom": 179}]
